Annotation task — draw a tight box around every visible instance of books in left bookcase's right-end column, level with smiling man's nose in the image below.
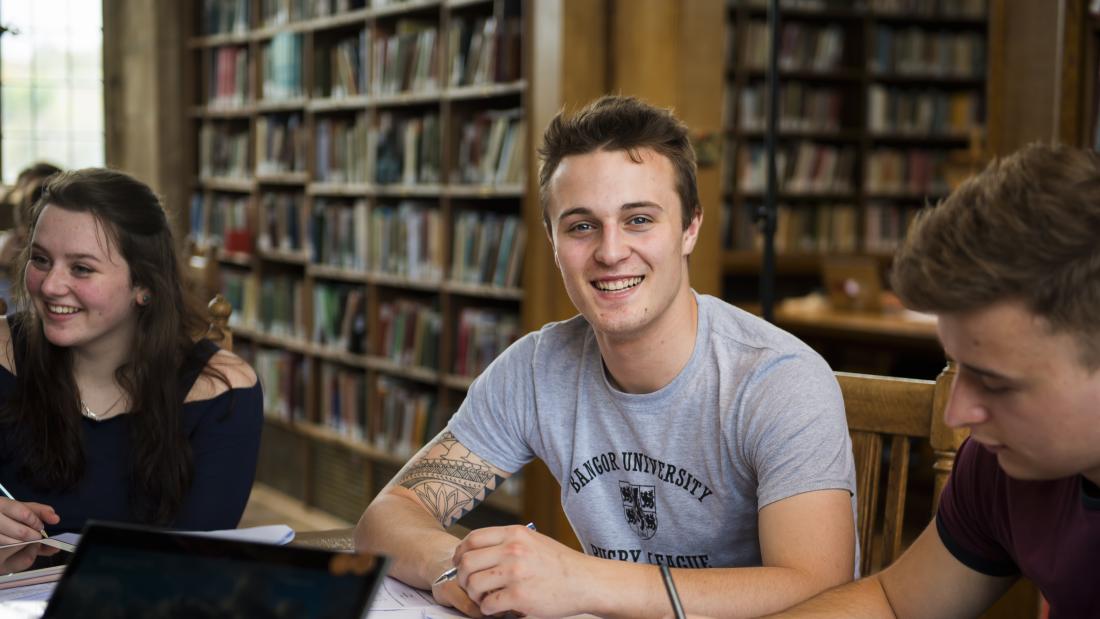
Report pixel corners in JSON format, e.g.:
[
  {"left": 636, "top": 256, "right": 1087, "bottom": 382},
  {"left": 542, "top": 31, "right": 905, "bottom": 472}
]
[{"left": 451, "top": 211, "right": 527, "bottom": 287}]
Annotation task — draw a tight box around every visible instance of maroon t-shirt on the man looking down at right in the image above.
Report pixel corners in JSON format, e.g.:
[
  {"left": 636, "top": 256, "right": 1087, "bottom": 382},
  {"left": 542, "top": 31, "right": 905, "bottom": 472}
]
[{"left": 936, "top": 441, "right": 1100, "bottom": 617}]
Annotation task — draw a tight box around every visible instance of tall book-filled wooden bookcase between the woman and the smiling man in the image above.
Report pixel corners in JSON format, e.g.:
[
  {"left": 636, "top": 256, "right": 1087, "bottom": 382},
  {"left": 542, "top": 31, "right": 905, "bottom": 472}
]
[{"left": 189, "top": 0, "right": 528, "bottom": 523}]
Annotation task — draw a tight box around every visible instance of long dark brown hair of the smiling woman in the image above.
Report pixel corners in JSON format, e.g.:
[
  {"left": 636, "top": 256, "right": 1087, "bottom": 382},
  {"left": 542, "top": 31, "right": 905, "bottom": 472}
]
[{"left": 0, "top": 168, "right": 216, "bottom": 524}]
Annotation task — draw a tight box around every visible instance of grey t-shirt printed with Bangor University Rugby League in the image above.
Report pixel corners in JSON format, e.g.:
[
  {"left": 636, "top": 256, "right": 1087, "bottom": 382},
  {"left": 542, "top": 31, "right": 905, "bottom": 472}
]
[{"left": 450, "top": 295, "right": 855, "bottom": 567}]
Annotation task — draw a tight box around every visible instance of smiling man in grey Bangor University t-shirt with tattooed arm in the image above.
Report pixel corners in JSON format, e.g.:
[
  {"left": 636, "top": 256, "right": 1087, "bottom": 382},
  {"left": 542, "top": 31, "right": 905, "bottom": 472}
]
[{"left": 356, "top": 97, "right": 856, "bottom": 618}]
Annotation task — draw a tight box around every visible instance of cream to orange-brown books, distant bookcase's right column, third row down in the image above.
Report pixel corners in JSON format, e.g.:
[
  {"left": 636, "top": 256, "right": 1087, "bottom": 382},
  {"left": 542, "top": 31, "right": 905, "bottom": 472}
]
[{"left": 867, "top": 85, "right": 982, "bottom": 135}]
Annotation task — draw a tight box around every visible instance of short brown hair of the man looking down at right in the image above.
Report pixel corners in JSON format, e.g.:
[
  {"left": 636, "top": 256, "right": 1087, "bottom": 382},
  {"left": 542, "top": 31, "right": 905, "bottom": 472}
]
[{"left": 892, "top": 144, "right": 1100, "bottom": 369}]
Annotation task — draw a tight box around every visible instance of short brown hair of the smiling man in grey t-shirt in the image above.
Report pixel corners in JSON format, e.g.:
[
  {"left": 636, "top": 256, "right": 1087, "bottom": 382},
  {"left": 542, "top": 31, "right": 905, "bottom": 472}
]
[{"left": 539, "top": 96, "right": 703, "bottom": 230}]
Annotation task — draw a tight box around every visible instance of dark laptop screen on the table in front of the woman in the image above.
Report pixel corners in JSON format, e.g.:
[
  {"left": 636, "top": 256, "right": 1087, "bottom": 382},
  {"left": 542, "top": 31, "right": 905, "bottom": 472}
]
[{"left": 43, "top": 523, "right": 388, "bottom": 619}]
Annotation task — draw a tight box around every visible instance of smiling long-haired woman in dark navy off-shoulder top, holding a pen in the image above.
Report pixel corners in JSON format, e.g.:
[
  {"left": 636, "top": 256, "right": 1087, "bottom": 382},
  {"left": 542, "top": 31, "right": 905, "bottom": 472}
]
[{"left": 0, "top": 168, "right": 263, "bottom": 544}]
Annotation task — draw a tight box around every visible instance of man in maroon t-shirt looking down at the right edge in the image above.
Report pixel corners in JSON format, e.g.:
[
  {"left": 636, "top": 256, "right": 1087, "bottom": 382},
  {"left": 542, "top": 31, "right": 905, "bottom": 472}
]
[{"left": 782, "top": 145, "right": 1100, "bottom": 618}]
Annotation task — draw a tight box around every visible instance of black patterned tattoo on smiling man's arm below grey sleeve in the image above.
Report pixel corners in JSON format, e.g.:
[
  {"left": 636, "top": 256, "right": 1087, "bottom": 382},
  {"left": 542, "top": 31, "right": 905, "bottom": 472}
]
[{"left": 398, "top": 432, "right": 505, "bottom": 528}]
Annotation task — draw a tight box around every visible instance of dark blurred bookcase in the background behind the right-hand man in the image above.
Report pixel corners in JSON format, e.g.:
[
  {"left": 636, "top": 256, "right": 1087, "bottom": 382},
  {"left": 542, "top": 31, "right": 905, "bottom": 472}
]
[{"left": 721, "top": 0, "right": 991, "bottom": 303}]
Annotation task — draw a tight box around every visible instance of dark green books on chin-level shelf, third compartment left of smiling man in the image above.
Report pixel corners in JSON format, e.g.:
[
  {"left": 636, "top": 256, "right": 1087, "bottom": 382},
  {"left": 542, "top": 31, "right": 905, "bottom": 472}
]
[{"left": 311, "top": 280, "right": 367, "bottom": 354}]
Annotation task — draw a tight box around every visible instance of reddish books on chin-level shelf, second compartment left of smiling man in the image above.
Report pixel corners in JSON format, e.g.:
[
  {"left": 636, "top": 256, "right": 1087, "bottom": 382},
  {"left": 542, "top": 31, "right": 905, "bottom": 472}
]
[{"left": 378, "top": 299, "right": 443, "bottom": 369}]
